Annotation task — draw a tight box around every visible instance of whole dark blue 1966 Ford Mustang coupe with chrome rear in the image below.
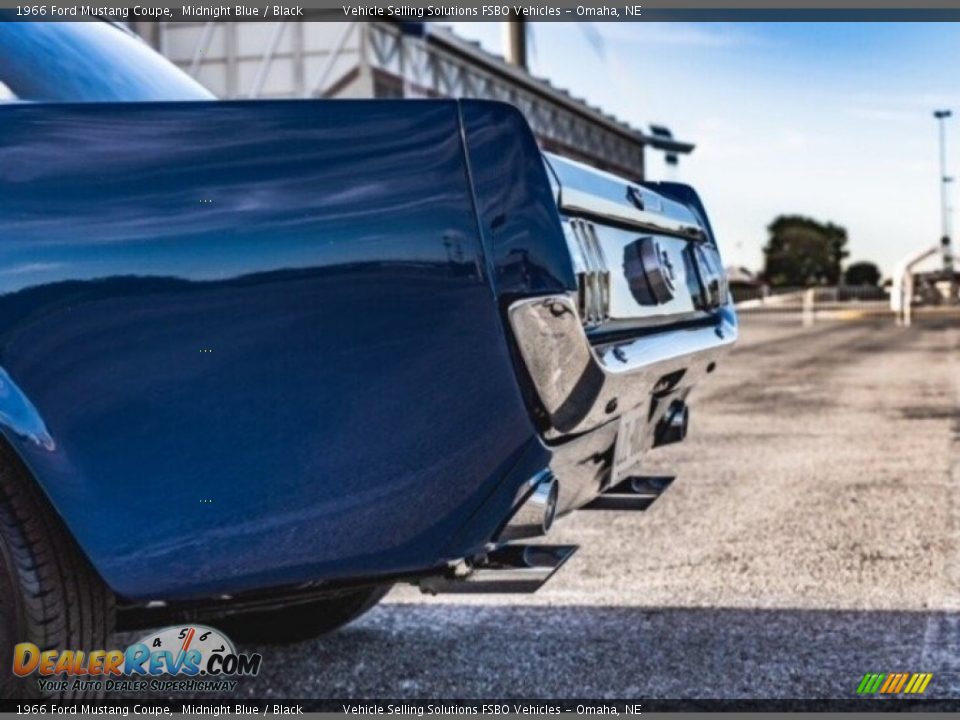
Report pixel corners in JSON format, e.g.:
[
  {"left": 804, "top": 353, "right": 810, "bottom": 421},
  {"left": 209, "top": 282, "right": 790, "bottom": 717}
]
[{"left": 0, "top": 22, "right": 737, "bottom": 694}]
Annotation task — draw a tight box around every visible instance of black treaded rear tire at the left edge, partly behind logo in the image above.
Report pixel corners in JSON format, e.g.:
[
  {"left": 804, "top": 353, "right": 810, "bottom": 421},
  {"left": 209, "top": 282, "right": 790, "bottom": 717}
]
[{"left": 0, "top": 441, "right": 115, "bottom": 700}]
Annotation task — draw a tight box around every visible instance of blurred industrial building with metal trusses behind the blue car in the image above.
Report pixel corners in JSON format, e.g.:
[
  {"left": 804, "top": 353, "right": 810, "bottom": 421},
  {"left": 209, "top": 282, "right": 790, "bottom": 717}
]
[{"left": 131, "top": 21, "right": 694, "bottom": 181}]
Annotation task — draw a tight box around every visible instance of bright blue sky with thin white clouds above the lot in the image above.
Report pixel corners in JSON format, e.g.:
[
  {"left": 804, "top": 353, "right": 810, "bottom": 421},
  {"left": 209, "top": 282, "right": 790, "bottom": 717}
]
[{"left": 452, "top": 22, "right": 960, "bottom": 275}]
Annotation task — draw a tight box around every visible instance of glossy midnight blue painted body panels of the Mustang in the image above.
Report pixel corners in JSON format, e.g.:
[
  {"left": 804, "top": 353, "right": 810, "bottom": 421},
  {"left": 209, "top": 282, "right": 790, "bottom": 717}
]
[{"left": 0, "top": 23, "right": 735, "bottom": 601}]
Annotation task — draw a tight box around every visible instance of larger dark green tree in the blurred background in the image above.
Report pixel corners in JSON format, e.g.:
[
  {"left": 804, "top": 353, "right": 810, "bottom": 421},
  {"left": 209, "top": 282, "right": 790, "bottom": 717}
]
[{"left": 763, "top": 215, "right": 849, "bottom": 287}]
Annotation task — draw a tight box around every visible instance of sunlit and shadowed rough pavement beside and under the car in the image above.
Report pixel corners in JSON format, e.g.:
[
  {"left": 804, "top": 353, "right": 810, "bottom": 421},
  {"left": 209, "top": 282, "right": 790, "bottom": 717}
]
[{"left": 158, "top": 318, "right": 960, "bottom": 698}]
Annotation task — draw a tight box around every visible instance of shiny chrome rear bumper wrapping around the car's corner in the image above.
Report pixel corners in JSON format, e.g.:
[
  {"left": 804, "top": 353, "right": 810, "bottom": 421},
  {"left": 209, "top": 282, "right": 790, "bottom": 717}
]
[{"left": 508, "top": 295, "right": 737, "bottom": 438}]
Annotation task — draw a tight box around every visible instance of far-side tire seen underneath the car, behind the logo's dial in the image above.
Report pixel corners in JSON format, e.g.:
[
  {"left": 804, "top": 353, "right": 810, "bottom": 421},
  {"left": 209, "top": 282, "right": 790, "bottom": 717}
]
[{"left": 210, "top": 585, "right": 392, "bottom": 645}]
